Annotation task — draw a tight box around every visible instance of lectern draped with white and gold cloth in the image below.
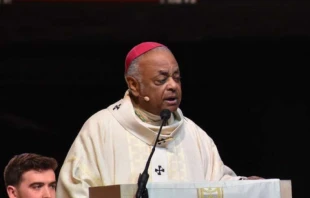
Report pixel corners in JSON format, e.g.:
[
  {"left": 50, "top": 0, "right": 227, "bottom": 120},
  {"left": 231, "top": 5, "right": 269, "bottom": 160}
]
[{"left": 89, "top": 179, "right": 292, "bottom": 198}]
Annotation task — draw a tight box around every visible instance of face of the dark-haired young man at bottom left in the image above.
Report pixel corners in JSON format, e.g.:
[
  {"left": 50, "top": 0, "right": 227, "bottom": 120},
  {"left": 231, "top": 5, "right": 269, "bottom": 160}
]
[{"left": 8, "top": 170, "right": 56, "bottom": 198}]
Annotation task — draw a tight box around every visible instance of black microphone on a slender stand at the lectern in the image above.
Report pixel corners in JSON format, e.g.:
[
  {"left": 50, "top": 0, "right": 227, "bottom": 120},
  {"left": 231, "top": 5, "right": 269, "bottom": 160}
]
[{"left": 136, "top": 109, "right": 171, "bottom": 198}]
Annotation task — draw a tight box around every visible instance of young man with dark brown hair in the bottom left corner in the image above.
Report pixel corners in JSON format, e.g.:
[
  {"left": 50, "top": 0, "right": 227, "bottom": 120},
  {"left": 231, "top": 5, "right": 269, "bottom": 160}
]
[{"left": 4, "top": 153, "right": 58, "bottom": 198}]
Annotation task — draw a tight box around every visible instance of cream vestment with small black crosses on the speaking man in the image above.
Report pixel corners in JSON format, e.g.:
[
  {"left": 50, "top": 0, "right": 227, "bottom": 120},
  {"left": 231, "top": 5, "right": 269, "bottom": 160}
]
[{"left": 56, "top": 92, "right": 240, "bottom": 198}]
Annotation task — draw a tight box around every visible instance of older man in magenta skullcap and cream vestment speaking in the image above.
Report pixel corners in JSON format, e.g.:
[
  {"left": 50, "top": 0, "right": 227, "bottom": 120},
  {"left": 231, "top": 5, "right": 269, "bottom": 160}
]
[{"left": 57, "top": 42, "right": 262, "bottom": 198}]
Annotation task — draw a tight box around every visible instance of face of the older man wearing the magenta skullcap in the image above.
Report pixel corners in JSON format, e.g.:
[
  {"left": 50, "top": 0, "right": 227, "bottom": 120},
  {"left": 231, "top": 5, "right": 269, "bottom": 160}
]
[{"left": 139, "top": 50, "right": 182, "bottom": 115}]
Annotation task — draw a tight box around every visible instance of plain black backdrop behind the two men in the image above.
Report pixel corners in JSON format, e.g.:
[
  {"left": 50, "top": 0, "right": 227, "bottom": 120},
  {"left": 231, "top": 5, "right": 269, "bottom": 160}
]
[{"left": 0, "top": 0, "right": 310, "bottom": 198}]
